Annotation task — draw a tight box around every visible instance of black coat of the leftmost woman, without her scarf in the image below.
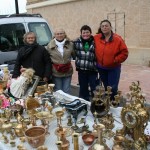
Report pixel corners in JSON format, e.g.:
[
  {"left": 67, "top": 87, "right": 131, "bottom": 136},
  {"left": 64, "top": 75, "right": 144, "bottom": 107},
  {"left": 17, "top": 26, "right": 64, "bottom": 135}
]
[{"left": 12, "top": 44, "right": 52, "bottom": 79}]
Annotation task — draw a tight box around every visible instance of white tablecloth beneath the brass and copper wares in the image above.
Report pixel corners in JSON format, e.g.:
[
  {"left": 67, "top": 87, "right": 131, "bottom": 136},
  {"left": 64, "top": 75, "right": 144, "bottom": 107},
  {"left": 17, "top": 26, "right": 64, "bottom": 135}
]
[{"left": 0, "top": 91, "right": 150, "bottom": 150}]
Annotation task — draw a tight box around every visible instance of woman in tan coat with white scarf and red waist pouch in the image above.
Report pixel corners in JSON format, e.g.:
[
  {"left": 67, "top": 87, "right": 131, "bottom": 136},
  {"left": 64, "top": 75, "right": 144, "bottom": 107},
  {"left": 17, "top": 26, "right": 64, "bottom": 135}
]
[{"left": 47, "top": 29, "right": 74, "bottom": 93}]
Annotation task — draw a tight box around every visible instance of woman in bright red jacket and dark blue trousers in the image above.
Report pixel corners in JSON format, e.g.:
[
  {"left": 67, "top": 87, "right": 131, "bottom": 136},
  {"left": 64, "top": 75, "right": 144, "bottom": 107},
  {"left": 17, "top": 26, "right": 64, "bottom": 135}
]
[{"left": 94, "top": 20, "right": 128, "bottom": 100}]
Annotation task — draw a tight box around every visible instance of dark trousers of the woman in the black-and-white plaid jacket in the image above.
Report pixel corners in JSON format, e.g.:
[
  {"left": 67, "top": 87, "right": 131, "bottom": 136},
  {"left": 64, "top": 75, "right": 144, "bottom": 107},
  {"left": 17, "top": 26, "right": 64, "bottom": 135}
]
[{"left": 78, "top": 70, "right": 97, "bottom": 101}]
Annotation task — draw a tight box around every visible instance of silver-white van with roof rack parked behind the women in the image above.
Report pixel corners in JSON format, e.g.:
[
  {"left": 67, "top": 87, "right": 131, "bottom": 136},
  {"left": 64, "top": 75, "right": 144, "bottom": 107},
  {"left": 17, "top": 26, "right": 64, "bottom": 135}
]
[{"left": 0, "top": 14, "right": 52, "bottom": 70}]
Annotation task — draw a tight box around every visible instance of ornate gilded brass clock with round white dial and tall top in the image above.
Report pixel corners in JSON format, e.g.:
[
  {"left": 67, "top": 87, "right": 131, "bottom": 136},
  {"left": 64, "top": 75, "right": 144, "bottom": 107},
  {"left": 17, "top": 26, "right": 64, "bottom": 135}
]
[{"left": 121, "top": 83, "right": 149, "bottom": 150}]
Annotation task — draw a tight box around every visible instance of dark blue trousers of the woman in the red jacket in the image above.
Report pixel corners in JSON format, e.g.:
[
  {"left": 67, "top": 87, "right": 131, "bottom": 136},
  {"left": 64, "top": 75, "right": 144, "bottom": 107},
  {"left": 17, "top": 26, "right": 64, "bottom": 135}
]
[{"left": 98, "top": 66, "right": 121, "bottom": 100}]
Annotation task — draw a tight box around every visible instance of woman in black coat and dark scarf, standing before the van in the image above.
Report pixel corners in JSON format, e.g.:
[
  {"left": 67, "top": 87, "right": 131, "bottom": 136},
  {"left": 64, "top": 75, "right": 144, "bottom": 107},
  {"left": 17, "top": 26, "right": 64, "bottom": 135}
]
[{"left": 12, "top": 32, "right": 52, "bottom": 82}]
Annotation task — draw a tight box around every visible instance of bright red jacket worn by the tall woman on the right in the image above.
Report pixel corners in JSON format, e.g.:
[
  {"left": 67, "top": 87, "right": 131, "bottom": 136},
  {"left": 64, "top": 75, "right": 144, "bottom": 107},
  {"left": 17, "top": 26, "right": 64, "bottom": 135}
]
[{"left": 94, "top": 33, "right": 128, "bottom": 68}]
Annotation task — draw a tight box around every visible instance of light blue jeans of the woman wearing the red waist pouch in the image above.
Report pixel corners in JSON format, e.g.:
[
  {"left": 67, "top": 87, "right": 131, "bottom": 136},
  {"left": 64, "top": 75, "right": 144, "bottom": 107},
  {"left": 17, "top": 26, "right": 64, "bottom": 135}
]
[{"left": 53, "top": 76, "right": 72, "bottom": 93}]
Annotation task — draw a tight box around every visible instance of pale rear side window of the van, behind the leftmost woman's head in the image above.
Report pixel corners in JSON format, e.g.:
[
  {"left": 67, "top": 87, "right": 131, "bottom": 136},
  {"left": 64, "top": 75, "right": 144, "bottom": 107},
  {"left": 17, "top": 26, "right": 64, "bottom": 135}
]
[{"left": 28, "top": 22, "right": 52, "bottom": 46}]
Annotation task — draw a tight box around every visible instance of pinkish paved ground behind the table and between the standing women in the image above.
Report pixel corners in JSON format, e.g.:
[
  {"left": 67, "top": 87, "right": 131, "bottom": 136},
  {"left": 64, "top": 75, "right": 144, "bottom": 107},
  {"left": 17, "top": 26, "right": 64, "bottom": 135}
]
[{"left": 72, "top": 62, "right": 150, "bottom": 103}]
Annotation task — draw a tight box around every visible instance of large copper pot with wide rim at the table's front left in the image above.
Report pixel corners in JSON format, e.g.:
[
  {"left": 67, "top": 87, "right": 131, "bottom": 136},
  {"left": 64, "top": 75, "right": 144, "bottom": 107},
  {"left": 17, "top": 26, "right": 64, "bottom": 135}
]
[{"left": 25, "top": 126, "right": 46, "bottom": 148}]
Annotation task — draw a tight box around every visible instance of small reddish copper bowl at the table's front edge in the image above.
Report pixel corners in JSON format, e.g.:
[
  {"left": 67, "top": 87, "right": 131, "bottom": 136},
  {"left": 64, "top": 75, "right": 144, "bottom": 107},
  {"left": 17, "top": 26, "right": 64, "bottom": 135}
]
[{"left": 82, "top": 134, "right": 95, "bottom": 145}]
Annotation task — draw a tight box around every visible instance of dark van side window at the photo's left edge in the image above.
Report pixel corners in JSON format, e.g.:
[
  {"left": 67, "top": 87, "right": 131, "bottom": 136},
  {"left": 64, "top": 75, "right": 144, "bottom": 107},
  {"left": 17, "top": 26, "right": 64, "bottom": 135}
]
[{"left": 0, "top": 23, "right": 25, "bottom": 52}]
